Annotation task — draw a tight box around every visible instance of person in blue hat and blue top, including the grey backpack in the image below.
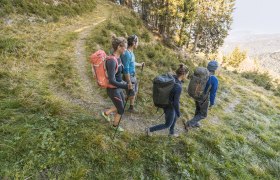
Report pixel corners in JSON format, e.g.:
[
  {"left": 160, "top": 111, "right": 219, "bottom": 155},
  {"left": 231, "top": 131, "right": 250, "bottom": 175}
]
[{"left": 186, "top": 60, "right": 219, "bottom": 130}]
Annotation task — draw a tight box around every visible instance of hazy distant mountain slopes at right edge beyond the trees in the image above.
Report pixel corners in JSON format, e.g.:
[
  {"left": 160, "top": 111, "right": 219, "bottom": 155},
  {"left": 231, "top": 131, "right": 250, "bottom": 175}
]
[{"left": 220, "top": 32, "right": 280, "bottom": 79}]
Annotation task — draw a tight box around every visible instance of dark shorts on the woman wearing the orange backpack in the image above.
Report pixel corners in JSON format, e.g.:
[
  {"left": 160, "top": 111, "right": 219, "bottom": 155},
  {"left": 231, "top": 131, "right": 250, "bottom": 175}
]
[{"left": 107, "top": 88, "right": 125, "bottom": 115}]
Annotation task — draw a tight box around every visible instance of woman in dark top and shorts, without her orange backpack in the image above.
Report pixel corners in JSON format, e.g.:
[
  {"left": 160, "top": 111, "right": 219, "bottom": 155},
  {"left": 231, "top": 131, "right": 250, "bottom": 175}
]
[{"left": 101, "top": 36, "right": 133, "bottom": 131}]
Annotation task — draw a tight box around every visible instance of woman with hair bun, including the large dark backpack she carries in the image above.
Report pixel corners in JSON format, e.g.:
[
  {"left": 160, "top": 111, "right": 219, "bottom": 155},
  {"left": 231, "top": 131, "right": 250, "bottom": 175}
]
[{"left": 146, "top": 64, "right": 188, "bottom": 137}]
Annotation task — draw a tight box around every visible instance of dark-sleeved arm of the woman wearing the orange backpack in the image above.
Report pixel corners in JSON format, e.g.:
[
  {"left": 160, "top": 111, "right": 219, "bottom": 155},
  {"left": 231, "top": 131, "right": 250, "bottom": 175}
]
[{"left": 106, "top": 59, "right": 128, "bottom": 89}]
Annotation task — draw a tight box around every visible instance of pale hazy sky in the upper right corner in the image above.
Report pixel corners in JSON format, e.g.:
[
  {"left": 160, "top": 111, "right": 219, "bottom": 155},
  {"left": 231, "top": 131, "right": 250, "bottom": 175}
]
[{"left": 232, "top": 0, "right": 280, "bottom": 34}]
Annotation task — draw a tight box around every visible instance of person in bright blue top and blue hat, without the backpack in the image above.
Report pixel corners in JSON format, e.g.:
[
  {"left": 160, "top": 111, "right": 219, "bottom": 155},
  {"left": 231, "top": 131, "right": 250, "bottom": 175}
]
[{"left": 186, "top": 60, "right": 219, "bottom": 128}]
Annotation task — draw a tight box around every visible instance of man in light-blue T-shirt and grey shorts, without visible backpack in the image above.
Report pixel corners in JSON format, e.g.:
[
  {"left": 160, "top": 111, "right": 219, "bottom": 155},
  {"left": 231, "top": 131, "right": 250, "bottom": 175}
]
[{"left": 121, "top": 35, "right": 145, "bottom": 112}]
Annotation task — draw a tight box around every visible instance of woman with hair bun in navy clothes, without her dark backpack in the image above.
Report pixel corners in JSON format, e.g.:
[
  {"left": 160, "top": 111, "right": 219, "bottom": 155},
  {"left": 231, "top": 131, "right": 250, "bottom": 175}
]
[{"left": 146, "top": 64, "right": 188, "bottom": 137}]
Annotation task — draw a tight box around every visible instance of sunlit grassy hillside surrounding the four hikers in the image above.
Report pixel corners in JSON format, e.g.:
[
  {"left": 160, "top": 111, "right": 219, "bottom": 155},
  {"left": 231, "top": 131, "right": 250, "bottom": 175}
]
[{"left": 0, "top": 1, "right": 280, "bottom": 179}]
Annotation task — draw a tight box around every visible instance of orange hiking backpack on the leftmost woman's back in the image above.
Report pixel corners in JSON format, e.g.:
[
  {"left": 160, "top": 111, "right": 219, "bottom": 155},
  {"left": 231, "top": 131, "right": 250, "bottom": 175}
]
[{"left": 90, "top": 50, "right": 118, "bottom": 88}]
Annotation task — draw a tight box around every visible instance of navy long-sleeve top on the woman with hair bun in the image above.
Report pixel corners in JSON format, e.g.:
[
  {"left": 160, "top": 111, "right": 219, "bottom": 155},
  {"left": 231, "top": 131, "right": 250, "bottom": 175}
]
[{"left": 169, "top": 76, "right": 182, "bottom": 117}]
